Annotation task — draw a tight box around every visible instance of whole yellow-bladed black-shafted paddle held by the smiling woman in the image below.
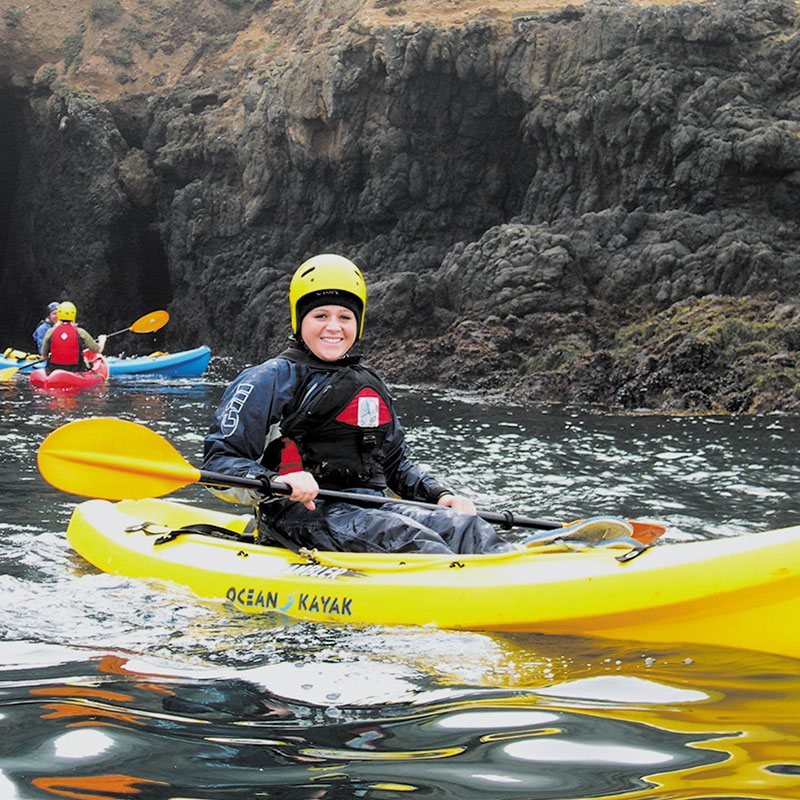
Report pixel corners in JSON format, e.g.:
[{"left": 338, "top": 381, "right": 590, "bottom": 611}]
[{"left": 37, "top": 417, "right": 665, "bottom": 544}]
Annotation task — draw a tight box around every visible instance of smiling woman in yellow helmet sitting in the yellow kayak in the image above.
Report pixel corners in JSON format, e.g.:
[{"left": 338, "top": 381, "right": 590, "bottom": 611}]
[{"left": 202, "top": 254, "right": 516, "bottom": 553}]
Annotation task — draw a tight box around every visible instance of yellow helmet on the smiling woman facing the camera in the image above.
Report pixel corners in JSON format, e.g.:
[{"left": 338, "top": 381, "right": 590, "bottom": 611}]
[{"left": 289, "top": 253, "right": 367, "bottom": 339}]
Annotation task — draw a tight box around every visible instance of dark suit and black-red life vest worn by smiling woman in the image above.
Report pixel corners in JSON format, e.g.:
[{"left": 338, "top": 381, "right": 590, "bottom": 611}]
[{"left": 203, "top": 345, "right": 515, "bottom": 553}]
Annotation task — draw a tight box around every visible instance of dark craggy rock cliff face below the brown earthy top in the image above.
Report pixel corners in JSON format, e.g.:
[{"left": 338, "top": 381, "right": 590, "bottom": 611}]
[{"left": 0, "top": 0, "right": 800, "bottom": 411}]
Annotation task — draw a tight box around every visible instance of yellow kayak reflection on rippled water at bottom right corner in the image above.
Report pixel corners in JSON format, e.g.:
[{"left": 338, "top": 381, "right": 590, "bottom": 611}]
[{"left": 482, "top": 636, "right": 800, "bottom": 800}]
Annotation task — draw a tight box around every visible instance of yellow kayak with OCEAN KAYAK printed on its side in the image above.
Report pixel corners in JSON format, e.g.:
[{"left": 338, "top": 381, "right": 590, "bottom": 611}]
[{"left": 67, "top": 500, "right": 800, "bottom": 657}]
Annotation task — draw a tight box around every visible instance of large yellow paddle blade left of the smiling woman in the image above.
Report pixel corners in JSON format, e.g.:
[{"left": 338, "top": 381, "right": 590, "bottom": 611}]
[{"left": 37, "top": 417, "right": 200, "bottom": 500}]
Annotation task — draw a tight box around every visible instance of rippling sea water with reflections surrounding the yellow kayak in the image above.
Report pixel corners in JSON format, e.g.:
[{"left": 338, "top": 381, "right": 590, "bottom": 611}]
[{"left": 0, "top": 368, "right": 800, "bottom": 800}]
